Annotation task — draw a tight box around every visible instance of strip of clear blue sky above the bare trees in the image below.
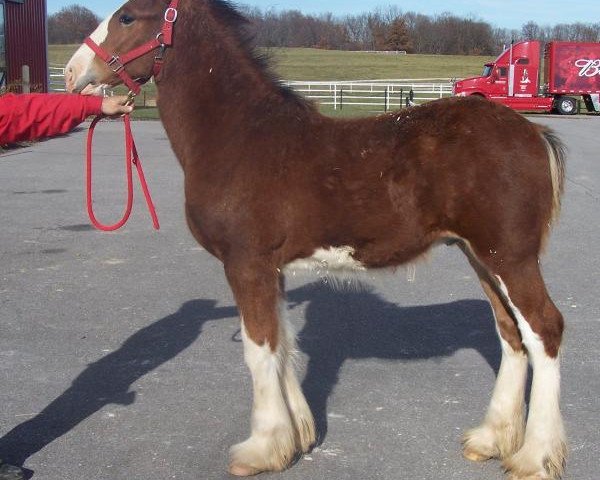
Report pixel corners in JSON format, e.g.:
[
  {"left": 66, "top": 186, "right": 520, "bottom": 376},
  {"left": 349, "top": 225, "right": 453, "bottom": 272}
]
[{"left": 47, "top": 0, "right": 600, "bottom": 29}]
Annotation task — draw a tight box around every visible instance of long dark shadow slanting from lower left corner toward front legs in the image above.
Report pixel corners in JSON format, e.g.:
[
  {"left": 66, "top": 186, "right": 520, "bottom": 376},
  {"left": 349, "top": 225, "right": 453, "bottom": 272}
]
[{"left": 0, "top": 300, "right": 237, "bottom": 478}]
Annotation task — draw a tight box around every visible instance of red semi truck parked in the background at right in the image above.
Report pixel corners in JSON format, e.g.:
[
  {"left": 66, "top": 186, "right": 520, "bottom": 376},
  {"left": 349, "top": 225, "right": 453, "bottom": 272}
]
[{"left": 453, "top": 40, "right": 600, "bottom": 115}]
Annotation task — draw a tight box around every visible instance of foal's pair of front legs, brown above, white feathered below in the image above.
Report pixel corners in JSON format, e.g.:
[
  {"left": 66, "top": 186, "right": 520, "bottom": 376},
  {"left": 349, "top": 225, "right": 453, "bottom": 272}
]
[{"left": 225, "top": 261, "right": 314, "bottom": 476}]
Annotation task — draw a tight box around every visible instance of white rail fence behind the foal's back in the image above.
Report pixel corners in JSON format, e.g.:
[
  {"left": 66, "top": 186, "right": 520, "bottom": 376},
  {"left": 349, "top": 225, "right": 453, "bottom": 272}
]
[{"left": 284, "top": 78, "right": 452, "bottom": 111}]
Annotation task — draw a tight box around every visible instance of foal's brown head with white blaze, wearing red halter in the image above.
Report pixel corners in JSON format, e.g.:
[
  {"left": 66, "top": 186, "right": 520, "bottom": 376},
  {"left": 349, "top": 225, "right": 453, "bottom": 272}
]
[{"left": 65, "top": 0, "right": 177, "bottom": 93}]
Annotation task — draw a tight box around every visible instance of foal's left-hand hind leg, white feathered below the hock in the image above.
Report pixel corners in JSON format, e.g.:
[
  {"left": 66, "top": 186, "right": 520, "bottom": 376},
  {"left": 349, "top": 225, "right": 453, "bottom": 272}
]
[{"left": 463, "top": 248, "right": 527, "bottom": 461}]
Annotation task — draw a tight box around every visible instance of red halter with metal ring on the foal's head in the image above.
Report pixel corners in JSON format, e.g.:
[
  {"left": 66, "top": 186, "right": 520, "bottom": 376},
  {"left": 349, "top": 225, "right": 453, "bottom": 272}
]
[{"left": 84, "top": 0, "right": 179, "bottom": 95}]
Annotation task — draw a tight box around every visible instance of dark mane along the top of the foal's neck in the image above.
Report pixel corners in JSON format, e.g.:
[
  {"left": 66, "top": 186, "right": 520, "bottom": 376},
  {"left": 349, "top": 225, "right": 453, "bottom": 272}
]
[{"left": 207, "top": 0, "right": 316, "bottom": 110}]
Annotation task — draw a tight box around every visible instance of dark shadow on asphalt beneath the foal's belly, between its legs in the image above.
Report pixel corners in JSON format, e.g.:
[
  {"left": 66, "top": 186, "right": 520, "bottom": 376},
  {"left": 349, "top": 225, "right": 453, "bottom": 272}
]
[{"left": 288, "top": 283, "right": 501, "bottom": 444}]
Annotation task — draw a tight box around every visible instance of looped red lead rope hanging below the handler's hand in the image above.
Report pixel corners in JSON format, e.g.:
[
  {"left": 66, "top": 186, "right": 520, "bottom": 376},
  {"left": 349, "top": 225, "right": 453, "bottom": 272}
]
[{"left": 86, "top": 115, "right": 160, "bottom": 232}]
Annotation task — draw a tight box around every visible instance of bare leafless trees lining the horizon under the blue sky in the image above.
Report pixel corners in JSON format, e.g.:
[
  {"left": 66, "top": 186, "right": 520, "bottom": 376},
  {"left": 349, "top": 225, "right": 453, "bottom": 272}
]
[{"left": 48, "top": 5, "right": 600, "bottom": 55}]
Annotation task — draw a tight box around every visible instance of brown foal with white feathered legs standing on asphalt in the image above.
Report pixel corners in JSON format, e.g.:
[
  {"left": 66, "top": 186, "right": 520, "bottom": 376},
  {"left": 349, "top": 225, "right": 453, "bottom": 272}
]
[{"left": 67, "top": 0, "right": 565, "bottom": 480}]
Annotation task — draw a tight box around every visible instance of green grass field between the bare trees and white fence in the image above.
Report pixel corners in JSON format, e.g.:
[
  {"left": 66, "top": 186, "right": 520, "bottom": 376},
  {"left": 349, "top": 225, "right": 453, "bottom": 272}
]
[{"left": 48, "top": 45, "right": 491, "bottom": 118}]
